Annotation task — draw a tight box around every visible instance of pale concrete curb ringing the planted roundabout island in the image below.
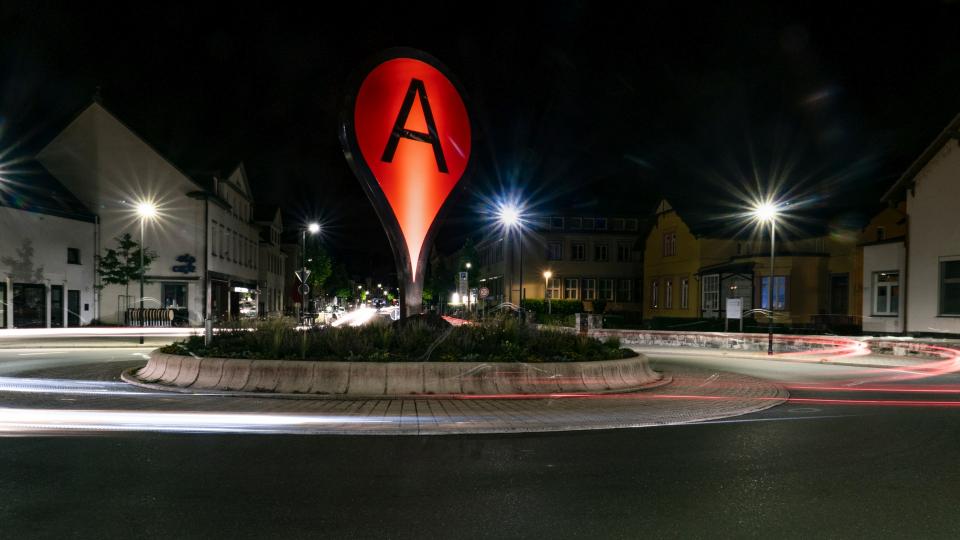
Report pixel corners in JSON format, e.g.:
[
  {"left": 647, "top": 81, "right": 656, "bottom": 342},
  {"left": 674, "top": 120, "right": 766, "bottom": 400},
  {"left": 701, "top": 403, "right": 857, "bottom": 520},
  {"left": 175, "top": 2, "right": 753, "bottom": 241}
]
[{"left": 122, "top": 351, "right": 666, "bottom": 399}]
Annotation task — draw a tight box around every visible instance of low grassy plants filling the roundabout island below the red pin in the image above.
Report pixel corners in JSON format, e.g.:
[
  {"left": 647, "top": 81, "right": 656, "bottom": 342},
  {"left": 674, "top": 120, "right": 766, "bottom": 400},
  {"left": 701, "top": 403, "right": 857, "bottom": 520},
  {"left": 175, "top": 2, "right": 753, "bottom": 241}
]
[{"left": 161, "top": 317, "right": 635, "bottom": 362}]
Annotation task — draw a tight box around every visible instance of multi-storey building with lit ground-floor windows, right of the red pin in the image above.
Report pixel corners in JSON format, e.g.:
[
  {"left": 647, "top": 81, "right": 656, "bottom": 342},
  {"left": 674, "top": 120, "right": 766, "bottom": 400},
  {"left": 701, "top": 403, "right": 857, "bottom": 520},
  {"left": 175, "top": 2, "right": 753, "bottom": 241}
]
[{"left": 476, "top": 215, "right": 643, "bottom": 311}]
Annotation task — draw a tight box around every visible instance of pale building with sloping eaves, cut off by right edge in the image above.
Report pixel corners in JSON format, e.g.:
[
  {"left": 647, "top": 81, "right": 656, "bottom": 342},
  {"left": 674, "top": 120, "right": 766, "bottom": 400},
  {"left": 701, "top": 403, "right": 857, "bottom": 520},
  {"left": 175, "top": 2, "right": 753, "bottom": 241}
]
[{"left": 880, "top": 116, "right": 960, "bottom": 334}]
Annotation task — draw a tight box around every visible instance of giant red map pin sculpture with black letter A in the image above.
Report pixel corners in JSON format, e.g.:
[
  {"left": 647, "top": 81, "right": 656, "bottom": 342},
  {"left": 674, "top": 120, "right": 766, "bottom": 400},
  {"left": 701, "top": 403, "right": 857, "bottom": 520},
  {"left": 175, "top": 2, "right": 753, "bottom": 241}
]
[{"left": 340, "top": 49, "right": 473, "bottom": 317}]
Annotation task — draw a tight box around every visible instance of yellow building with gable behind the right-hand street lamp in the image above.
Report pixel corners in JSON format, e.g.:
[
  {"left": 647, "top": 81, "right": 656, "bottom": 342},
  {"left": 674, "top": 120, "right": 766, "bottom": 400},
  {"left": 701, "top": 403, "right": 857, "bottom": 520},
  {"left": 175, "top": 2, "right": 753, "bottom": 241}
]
[{"left": 643, "top": 200, "right": 860, "bottom": 326}]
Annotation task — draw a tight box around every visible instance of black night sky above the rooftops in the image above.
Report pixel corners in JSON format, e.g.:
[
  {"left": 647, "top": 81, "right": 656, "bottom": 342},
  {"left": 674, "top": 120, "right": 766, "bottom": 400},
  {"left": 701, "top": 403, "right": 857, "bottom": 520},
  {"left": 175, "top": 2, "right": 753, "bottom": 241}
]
[{"left": 0, "top": 2, "right": 960, "bottom": 274}]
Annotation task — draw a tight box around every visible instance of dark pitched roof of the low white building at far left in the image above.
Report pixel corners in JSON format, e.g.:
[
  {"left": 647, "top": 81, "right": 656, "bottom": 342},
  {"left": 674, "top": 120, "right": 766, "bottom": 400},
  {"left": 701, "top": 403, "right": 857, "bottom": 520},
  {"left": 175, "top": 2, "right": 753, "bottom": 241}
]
[{"left": 0, "top": 159, "right": 96, "bottom": 222}]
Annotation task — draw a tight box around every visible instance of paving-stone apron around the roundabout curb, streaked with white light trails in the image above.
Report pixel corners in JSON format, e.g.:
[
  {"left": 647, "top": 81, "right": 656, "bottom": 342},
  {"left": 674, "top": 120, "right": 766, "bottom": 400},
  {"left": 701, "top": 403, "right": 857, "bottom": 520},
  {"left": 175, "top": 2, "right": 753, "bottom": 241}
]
[{"left": 0, "top": 362, "right": 788, "bottom": 435}]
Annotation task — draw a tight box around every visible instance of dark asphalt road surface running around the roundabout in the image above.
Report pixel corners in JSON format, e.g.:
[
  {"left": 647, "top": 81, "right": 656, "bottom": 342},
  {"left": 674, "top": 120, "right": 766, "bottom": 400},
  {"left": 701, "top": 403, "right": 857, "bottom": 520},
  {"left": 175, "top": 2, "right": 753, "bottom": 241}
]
[{"left": 0, "top": 350, "right": 960, "bottom": 538}]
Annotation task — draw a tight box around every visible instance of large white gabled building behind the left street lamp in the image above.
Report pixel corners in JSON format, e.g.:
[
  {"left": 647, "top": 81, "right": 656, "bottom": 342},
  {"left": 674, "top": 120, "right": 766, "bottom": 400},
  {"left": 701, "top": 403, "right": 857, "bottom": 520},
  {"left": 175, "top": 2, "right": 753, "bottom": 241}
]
[{"left": 37, "top": 101, "right": 259, "bottom": 325}]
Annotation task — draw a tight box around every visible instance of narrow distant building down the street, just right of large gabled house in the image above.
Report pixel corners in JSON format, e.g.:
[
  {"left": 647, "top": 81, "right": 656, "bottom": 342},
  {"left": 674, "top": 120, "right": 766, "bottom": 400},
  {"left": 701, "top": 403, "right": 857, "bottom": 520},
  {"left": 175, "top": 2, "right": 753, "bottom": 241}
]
[{"left": 254, "top": 206, "right": 287, "bottom": 316}]
